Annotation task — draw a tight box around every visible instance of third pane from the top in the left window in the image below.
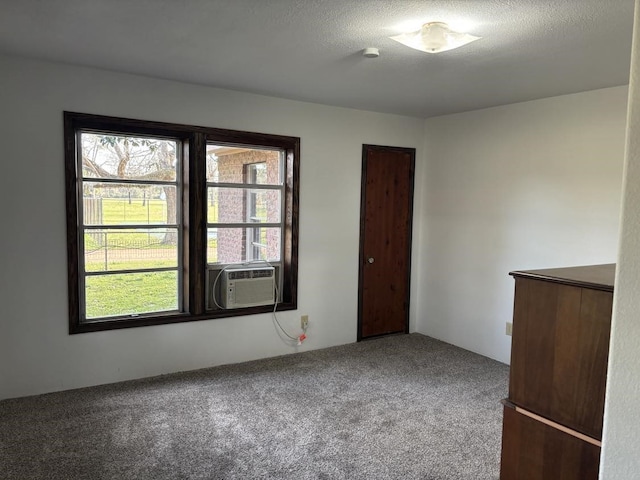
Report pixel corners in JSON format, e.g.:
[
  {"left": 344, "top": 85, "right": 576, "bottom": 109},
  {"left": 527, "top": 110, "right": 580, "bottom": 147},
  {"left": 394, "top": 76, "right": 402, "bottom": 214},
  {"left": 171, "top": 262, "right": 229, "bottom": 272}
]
[{"left": 84, "top": 228, "right": 178, "bottom": 272}]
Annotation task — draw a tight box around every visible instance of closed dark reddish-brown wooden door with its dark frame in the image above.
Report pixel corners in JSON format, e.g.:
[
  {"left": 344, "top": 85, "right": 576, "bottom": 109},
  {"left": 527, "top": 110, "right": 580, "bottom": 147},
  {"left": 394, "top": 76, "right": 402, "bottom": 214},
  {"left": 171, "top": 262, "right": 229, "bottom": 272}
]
[{"left": 358, "top": 145, "right": 415, "bottom": 340}]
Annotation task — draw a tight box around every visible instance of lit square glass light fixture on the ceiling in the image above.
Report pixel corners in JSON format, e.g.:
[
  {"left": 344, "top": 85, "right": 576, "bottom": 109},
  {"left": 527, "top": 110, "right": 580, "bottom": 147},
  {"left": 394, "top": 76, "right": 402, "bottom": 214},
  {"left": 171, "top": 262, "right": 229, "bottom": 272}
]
[{"left": 390, "top": 22, "right": 482, "bottom": 53}]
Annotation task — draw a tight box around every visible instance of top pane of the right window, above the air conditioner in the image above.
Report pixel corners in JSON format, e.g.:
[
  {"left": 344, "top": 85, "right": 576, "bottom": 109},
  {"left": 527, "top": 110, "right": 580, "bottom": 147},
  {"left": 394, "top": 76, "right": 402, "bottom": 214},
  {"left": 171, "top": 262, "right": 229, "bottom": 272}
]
[{"left": 207, "top": 144, "right": 284, "bottom": 185}]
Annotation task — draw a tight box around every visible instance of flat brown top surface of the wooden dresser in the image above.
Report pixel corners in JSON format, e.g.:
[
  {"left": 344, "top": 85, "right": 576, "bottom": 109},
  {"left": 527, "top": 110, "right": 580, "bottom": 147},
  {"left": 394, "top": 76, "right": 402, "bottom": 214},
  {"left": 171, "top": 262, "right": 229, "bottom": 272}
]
[{"left": 509, "top": 263, "right": 616, "bottom": 292}]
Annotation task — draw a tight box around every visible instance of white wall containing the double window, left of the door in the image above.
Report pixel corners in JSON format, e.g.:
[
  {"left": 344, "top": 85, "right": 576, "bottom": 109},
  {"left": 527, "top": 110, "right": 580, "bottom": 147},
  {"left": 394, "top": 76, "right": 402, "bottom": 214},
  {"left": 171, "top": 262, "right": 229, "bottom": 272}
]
[{"left": 0, "top": 56, "right": 424, "bottom": 398}]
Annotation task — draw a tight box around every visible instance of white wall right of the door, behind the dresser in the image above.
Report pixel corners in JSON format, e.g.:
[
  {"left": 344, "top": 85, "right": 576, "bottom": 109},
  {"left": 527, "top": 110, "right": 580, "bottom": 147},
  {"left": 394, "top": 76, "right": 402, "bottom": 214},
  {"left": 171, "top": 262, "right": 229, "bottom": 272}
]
[{"left": 416, "top": 87, "right": 627, "bottom": 362}]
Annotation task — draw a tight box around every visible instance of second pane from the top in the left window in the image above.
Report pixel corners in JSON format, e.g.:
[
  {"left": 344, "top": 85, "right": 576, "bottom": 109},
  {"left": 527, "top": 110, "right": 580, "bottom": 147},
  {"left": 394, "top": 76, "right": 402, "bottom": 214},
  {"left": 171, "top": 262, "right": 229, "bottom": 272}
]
[{"left": 82, "top": 186, "right": 177, "bottom": 225}]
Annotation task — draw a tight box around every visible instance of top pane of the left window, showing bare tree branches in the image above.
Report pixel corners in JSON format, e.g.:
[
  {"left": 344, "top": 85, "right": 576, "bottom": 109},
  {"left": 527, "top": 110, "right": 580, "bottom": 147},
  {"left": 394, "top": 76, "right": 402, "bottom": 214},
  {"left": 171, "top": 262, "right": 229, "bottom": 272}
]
[{"left": 81, "top": 132, "right": 177, "bottom": 181}]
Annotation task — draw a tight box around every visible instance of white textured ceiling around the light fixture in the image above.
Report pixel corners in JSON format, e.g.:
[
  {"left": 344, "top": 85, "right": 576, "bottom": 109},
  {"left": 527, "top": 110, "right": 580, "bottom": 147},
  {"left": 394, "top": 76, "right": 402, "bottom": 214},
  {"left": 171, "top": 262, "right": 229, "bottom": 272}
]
[{"left": 0, "top": 0, "right": 634, "bottom": 117}]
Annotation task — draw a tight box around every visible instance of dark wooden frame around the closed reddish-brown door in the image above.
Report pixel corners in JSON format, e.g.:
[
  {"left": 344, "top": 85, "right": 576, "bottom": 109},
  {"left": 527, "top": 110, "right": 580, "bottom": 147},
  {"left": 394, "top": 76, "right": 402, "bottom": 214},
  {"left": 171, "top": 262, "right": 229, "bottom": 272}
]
[{"left": 357, "top": 143, "right": 416, "bottom": 342}]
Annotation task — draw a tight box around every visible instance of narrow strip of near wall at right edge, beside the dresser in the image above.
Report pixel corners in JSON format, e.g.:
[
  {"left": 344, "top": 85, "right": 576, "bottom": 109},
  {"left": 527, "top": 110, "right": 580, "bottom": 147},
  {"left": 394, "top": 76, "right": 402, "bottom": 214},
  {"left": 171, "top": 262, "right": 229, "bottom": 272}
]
[{"left": 600, "top": 1, "right": 640, "bottom": 480}]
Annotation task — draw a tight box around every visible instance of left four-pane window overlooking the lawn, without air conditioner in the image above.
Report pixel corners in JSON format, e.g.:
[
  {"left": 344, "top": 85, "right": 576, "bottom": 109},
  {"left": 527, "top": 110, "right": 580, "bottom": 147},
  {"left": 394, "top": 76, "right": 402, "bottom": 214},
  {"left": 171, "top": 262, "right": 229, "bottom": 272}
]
[{"left": 77, "top": 130, "right": 182, "bottom": 321}]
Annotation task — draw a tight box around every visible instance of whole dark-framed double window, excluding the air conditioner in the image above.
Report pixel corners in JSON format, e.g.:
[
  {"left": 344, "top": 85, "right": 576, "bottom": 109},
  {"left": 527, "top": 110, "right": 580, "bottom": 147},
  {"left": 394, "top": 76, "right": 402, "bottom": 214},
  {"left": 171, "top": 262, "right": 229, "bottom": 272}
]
[{"left": 65, "top": 112, "right": 300, "bottom": 333}]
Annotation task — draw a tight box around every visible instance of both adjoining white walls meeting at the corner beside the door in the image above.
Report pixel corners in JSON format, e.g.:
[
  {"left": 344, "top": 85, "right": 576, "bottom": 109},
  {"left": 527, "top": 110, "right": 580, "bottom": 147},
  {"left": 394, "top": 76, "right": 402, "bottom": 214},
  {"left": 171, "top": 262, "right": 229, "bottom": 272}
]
[{"left": 0, "top": 52, "right": 627, "bottom": 404}]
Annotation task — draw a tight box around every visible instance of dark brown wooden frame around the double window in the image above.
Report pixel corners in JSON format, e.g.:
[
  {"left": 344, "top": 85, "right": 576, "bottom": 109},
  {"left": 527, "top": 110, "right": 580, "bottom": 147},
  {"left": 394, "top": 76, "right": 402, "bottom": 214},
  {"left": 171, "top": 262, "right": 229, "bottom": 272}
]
[{"left": 64, "top": 111, "right": 300, "bottom": 334}]
